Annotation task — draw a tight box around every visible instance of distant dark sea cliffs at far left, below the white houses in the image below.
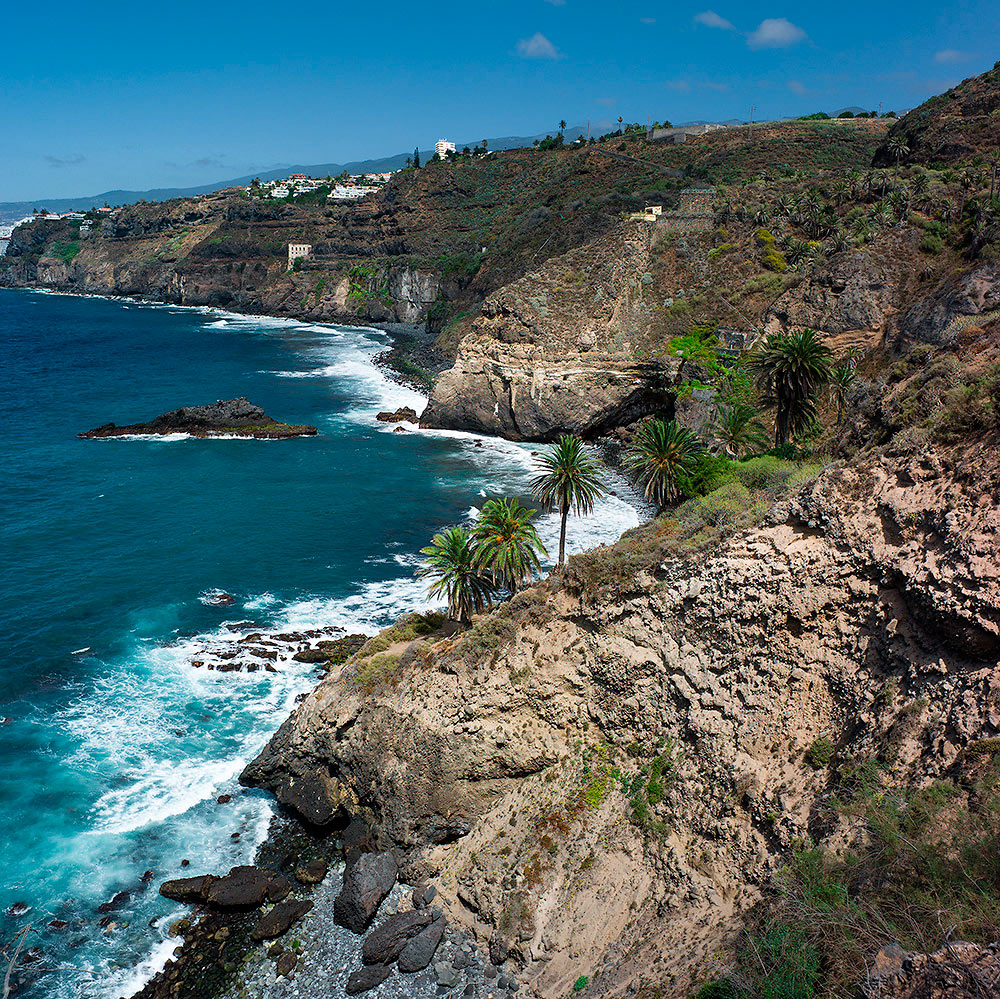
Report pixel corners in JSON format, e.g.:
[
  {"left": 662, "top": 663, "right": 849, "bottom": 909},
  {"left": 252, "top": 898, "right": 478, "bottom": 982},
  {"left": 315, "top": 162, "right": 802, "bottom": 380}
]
[{"left": 0, "top": 206, "right": 454, "bottom": 323}]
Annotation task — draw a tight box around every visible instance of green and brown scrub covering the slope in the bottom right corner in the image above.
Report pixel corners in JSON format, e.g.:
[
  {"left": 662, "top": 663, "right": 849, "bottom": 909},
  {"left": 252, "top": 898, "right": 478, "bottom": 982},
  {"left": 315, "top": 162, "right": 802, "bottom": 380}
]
[{"left": 698, "top": 753, "right": 1000, "bottom": 999}]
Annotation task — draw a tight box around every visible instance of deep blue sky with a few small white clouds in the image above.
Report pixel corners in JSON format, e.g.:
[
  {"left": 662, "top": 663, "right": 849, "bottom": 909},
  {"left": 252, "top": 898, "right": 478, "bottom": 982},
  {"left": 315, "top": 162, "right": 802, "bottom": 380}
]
[{"left": 0, "top": 0, "right": 1000, "bottom": 201}]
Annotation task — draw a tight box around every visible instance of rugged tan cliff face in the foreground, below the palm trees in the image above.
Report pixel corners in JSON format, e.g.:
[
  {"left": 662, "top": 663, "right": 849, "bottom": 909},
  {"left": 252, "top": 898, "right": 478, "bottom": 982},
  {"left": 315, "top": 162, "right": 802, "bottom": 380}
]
[{"left": 244, "top": 443, "right": 1000, "bottom": 996}]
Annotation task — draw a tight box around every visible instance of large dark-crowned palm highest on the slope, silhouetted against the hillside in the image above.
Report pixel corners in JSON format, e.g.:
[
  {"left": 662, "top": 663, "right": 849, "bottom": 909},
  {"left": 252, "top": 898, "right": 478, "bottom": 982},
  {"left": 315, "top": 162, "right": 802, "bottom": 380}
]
[{"left": 750, "top": 329, "right": 833, "bottom": 447}]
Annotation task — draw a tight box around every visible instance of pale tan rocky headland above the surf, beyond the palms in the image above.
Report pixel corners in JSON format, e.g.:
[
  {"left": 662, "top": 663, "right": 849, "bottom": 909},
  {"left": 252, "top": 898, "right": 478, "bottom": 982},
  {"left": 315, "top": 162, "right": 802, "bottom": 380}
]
[{"left": 420, "top": 223, "right": 674, "bottom": 441}]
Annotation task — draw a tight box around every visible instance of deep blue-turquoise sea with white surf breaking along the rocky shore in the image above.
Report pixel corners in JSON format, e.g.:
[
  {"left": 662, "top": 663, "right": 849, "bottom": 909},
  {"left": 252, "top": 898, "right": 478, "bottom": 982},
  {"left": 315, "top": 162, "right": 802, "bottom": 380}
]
[{"left": 0, "top": 290, "right": 638, "bottom": 999}]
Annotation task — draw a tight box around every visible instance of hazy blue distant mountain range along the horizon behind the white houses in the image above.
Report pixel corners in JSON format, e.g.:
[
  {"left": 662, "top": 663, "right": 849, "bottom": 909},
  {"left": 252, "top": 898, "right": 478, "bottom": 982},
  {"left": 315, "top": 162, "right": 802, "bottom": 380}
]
[{"left": 0, "top": 125, "right": 587, "bottom": 224}]
